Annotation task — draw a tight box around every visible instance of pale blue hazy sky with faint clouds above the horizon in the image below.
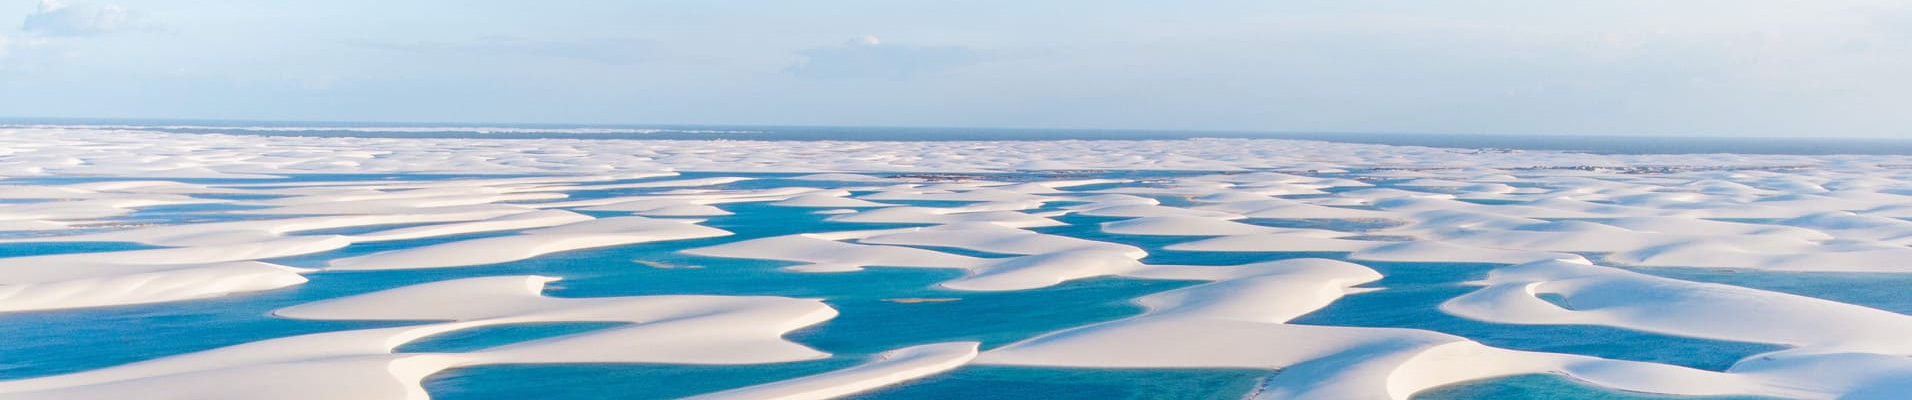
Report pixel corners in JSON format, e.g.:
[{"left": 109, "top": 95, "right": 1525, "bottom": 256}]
[{"left": 0, "top": 0, "right": 1912, "bottom": 138}]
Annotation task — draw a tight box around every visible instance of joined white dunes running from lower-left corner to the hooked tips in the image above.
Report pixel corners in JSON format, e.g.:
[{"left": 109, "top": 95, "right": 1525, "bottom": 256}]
[{"left": 0, "top": 276, "right": 836, "bottom": 400}]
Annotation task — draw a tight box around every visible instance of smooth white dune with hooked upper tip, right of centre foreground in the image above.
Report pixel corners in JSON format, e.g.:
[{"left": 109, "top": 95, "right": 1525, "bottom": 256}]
[{"left": 977, "top": 262, "right": 1440, "bottom": 367}]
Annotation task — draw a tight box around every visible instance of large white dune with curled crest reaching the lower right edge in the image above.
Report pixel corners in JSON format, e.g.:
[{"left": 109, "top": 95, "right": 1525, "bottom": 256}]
[{"left": 1442, "top": 262, "right": 1912, "bottom": 398}]
